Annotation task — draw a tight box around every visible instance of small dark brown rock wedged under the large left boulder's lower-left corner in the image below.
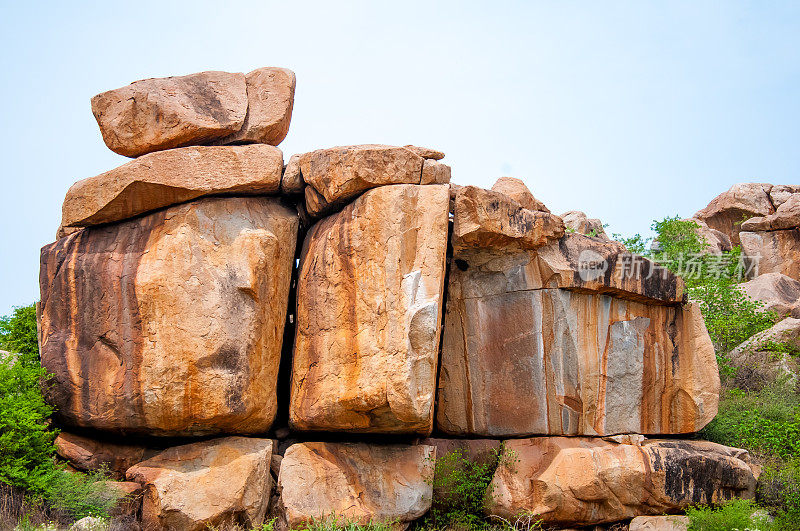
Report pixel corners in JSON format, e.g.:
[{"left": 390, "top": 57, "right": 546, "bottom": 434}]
[{"left": 55, "top": 431, "right": 159, "bottom": 479}]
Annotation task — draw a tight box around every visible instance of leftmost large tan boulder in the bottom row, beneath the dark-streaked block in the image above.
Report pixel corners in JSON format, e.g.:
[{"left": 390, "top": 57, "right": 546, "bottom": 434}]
[{"left": 127, "top": 437, "right": 272, "bottom": 531}]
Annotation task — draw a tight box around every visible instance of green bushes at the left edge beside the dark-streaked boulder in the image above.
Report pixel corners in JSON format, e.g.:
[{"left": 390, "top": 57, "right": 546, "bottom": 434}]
[{"left": 0, "top": 305, "right": 119, "bottom": 518}]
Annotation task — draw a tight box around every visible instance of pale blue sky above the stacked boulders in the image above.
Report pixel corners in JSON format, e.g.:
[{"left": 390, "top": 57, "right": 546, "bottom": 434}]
[{"left": 0, "top": 0, "right": 800, "bottom": 315}]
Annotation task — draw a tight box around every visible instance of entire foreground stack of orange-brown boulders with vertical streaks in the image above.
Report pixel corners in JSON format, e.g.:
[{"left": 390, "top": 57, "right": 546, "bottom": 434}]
[{"left": 39, "top": 68, "right": 755, "bottom": 529}]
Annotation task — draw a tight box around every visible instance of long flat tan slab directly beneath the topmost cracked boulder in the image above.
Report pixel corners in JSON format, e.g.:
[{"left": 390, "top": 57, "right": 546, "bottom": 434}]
[{"left": 61, "top": 145, "right": 283, "bottom": 230}]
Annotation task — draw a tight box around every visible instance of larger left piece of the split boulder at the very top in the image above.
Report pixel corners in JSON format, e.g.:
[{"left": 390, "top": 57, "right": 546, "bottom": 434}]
[{"left": 92, "top": 72, "right": 247, "bottom": 157}]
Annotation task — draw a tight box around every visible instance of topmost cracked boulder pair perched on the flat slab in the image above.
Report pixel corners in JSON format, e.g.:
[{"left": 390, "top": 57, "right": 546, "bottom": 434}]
[{"left": 92, "top": 68, "right": 295, "bottom": 157}]
